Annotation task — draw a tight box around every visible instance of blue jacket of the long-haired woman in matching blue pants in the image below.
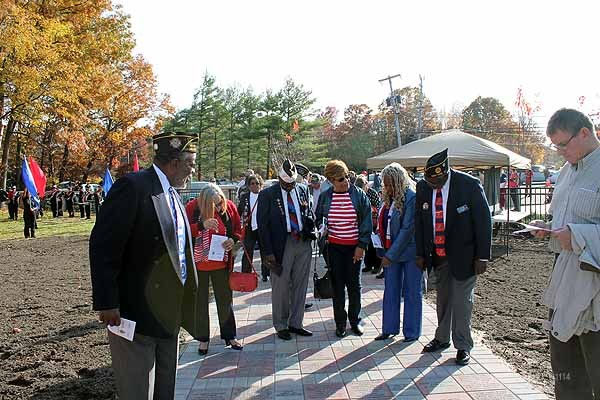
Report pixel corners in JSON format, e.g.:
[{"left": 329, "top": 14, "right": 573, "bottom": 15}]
[{"left": 377, "top": 189, "right": 417, "bottom": 264}]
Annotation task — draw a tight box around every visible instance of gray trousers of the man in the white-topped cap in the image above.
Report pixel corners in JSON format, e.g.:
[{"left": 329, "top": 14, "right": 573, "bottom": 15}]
[{"left": 271, "top": 235, "right": 312, "bottom": 331}]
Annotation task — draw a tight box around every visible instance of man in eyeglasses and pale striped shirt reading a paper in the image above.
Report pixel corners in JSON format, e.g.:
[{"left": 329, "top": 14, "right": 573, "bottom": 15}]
[{"left": 531, "top": 108, "right": 600, "bottom": 400}]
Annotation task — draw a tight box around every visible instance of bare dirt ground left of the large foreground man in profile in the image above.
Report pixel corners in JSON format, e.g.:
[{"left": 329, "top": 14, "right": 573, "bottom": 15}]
[{"left": 0, "top": 236, "right": 115, "bottom": 400}]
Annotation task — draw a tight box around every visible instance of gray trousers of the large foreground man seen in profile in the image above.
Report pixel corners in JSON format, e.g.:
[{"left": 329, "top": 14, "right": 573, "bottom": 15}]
[{"left": 108, "top": 333, "right": 179, "bottom": 400}]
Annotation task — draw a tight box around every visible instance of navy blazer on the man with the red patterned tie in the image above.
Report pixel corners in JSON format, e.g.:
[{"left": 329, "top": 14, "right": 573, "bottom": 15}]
[{"left": 415, "top": 169, "right": 492, "bottom": 280}]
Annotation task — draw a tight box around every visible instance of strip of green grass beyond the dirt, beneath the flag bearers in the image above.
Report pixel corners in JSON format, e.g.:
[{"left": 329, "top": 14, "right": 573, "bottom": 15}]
[{"left": 0, "top": 209, "right": 96, "bottom": 240}]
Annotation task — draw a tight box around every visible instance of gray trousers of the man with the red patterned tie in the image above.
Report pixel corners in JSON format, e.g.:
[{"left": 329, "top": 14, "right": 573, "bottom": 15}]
[{"left": 434, "top": 263, "right": 477, "bottom": 351}]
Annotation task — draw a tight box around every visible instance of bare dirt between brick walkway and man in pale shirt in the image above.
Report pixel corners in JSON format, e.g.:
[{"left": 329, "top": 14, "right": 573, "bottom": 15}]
[{"left": 473, "top": 239, "right": 554, "bottom": 396}]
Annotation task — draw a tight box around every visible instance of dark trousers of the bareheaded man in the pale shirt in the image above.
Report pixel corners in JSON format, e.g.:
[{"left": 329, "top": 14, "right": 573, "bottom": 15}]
[{"left": 550, "top": 332, "right": 600, "bottom": 400}]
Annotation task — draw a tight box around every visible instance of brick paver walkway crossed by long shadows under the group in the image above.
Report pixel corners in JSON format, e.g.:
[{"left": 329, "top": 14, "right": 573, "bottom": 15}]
[{"left": 176, "top": 255, "right": 547, "bottom": 400}]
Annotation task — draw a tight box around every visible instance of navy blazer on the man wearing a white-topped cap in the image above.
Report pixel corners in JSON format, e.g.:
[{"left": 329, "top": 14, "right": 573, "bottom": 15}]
[{"left": 256, "top": 182, "right": 314, "bottom": 264}]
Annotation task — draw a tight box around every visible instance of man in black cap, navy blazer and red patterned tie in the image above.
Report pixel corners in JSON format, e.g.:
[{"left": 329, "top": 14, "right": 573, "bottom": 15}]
[{"left": 415, "top": 149, "right": 492, "bottom": 365}]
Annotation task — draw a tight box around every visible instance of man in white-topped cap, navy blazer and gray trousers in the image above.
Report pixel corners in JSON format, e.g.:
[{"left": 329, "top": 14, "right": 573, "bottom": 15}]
[{"left": 257, "top": 160, "right": 315, "bottom": 340}]
